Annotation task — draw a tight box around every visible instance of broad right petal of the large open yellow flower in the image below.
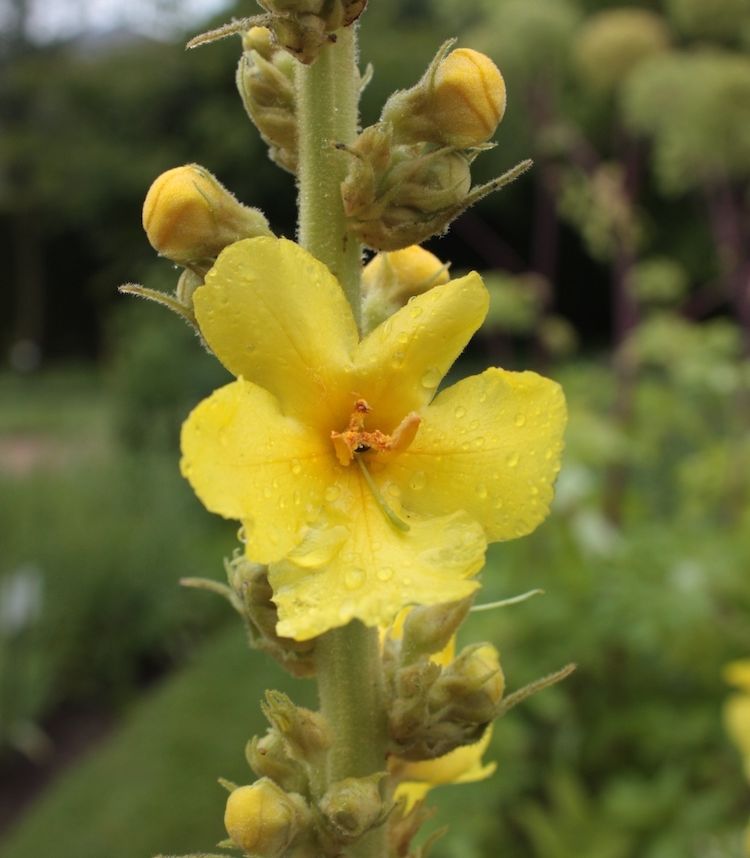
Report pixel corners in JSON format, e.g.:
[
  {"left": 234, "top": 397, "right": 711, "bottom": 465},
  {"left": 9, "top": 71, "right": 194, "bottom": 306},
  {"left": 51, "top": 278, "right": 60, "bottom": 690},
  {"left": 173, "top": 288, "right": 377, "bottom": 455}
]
[{"left": 384, "top": 368, "right": 566, "bottom": 542}]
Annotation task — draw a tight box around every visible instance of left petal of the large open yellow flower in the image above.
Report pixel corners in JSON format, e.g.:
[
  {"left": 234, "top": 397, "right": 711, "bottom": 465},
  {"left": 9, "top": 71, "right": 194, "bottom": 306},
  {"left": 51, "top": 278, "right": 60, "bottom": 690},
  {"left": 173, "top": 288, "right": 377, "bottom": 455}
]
[{"left": 180, "top": 380, "right": 337, "bottom": 563}]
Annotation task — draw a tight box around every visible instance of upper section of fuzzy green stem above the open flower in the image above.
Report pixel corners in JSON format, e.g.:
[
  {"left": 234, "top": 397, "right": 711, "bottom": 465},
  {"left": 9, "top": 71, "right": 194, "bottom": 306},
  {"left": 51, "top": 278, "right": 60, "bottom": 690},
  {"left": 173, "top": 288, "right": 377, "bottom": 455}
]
[{"left": 297, "top": 26, "right": 362, "bottom": 325}]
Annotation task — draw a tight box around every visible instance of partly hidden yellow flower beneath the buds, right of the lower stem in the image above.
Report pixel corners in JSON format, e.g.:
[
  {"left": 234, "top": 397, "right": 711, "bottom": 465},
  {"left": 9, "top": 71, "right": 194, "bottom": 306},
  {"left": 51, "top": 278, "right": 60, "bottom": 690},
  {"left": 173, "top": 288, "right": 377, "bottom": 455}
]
[{"left": 392, "top": 726, "right": 497, "bottom": 809}]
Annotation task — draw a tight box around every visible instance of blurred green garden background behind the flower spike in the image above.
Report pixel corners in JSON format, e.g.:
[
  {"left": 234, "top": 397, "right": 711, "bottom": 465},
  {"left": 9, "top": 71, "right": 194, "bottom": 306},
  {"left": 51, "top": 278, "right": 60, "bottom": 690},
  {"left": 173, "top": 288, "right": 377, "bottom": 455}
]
[{"left": 0, "top": 0, "right": 750, "bottom": 858}]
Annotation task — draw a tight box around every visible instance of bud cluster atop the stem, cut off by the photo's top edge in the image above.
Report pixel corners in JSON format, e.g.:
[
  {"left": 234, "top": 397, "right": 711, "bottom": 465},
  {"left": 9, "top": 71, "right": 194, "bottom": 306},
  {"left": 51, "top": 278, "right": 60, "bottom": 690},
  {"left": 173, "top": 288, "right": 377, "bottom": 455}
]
[{"left": 258, "top": 0, "right": 367, "bottom": 65}]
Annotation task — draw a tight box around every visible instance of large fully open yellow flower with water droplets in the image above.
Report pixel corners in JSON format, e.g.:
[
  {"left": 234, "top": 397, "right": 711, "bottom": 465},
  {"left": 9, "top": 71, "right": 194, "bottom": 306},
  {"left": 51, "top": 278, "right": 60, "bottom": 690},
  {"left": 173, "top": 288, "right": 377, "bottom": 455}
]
[{"left": 182, "top": 238, "right": 565, "bottom": 640}]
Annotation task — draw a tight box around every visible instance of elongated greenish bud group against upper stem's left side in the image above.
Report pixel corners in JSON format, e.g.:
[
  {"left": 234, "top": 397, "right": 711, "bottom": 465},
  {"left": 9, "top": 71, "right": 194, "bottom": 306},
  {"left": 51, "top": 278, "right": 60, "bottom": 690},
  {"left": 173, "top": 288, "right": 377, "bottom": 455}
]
[{"left": 236, "top": 27, "right": 297, "bottom": 173}]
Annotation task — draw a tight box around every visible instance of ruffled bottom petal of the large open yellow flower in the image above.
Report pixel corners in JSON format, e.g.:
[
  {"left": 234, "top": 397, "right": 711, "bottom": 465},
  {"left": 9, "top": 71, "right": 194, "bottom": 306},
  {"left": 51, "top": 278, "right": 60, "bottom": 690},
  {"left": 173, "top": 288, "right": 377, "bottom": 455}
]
[{"left": 269, "top": 473, "right": 486, "bottom": 640}]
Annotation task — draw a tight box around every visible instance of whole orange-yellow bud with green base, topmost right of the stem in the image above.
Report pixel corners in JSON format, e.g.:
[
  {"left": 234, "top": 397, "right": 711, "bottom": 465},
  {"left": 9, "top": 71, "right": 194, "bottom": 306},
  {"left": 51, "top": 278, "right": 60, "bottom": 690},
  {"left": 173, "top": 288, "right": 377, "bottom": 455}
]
[{"left": 381, "top": 41, "right": 506, "bottom": 149}]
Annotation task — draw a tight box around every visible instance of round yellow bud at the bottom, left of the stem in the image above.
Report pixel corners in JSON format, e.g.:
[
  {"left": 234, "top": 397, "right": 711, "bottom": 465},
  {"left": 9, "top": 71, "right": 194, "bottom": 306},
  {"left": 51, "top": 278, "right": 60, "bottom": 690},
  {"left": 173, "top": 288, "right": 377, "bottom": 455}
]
[{"left": 224, "top": 778, "right": 307, "bottom": 858}]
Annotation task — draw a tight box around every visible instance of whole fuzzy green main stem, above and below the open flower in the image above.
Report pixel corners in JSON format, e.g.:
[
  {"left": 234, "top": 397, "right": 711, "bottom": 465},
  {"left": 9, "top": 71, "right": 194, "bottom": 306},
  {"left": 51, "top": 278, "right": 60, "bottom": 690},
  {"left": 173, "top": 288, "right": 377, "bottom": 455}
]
[{"left": 297, "top": 21, "right": 387, "bottom": 858}]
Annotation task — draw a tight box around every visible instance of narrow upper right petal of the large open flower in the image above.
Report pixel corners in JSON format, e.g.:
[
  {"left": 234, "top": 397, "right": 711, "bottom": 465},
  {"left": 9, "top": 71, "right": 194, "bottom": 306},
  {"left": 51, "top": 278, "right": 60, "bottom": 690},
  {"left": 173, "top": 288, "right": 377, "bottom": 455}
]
[{"left": 355, "top": 273, "right": 489, "bottom": 431}]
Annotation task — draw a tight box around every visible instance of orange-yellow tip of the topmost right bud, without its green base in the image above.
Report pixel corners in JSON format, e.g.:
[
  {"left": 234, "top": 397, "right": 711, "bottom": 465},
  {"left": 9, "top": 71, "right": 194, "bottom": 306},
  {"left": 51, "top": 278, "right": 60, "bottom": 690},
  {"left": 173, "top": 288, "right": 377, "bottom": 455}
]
[{"left": 431, "top": 48, "right": 506, "bottom": 149}]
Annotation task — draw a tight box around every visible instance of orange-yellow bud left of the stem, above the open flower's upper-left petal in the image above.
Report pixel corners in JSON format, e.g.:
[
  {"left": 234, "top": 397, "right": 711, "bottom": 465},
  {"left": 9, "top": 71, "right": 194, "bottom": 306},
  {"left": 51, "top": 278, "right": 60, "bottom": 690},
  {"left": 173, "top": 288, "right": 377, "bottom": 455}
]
[{"left": 143, "top": 164, "right": 271, "bottom": 275}]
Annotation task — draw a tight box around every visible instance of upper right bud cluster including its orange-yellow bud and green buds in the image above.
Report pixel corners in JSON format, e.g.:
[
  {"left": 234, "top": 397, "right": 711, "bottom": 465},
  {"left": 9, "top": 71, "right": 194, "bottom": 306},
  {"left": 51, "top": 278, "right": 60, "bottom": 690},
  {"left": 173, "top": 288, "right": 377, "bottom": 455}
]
[{"left": 341, "top": 42, "right": 520, "bottom": 250}]
